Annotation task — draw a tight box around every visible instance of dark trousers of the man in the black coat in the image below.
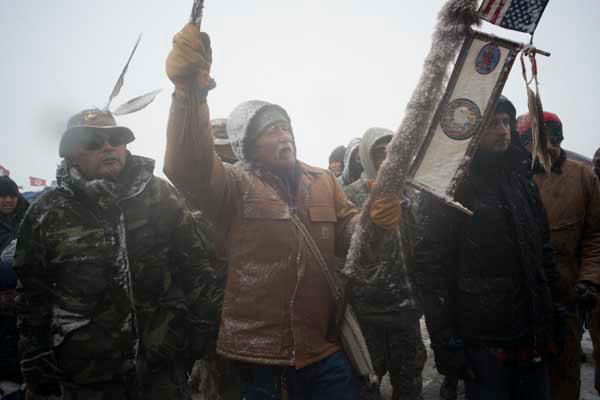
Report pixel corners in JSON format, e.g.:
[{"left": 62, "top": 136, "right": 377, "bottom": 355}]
[{"left": 465, "top": 348, "right": 550, "bottom": 400}]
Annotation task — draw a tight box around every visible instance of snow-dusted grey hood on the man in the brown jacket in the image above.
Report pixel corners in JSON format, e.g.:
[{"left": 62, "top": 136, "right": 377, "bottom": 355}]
[{"left": 227, "top": 100, "right": 291, "bottom": 161}]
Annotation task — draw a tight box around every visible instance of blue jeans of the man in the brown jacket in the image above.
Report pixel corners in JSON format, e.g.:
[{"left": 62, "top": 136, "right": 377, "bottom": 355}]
[{"left": 243, "top": 352, "right": 360, "bottom": 400}]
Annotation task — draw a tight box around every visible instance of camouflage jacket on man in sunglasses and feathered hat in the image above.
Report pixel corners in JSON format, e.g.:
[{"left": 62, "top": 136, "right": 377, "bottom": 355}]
[{"left": 15, "top": 155, "right": 222, "bottom": 383}]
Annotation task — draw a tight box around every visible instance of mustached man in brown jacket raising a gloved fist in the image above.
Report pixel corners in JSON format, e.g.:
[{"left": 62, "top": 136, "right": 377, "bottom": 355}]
[{"left": 164, "top": 24, "right": 401, "bottom": 399}]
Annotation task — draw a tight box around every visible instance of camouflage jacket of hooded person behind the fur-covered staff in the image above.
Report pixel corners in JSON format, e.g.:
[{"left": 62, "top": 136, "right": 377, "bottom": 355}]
[{"left": 343, "top": 177, "right": 422, "bottom": 328}]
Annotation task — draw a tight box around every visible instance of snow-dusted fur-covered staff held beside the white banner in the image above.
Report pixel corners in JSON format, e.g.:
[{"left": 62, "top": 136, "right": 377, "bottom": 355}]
[{"left": 343, "top": 0, "right": 479, "bottom": 276}]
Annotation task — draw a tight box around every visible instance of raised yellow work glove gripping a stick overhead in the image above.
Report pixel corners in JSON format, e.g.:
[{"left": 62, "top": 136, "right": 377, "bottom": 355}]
[{"left": 166, "top": 23, "right": 215, "bottom": 98}]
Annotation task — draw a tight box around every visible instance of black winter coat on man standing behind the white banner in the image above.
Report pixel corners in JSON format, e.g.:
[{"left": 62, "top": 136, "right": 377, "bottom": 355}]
[{"left": 415, "top": 139, "right": 559, "bottom": 351}]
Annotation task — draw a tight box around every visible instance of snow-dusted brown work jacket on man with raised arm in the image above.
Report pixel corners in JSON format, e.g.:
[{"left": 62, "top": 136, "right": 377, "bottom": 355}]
[{"left": 165, "top": 97, "right": 357, "bottom": 368}]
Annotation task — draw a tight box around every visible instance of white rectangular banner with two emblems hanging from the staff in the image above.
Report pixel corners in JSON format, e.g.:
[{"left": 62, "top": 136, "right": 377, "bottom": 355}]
[{"left": 409, "top": 31, "right": 522, "bottom": 212}]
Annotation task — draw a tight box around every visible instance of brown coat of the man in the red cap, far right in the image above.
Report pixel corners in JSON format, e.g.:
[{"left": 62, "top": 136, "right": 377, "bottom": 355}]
[{"left": 534, "top": 151, "right": 600, "bottom": 307}]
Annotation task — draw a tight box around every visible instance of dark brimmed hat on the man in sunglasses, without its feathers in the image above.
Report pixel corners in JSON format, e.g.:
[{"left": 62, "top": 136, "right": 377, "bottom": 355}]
[{"left": 58, "top": 108, "right": 135, "bottom": 158}]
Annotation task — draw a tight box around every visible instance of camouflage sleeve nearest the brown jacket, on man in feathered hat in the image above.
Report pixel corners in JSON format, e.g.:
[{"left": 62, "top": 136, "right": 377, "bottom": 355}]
[{"left": 169, "top": 186, "right": 226, "bottom": 356}]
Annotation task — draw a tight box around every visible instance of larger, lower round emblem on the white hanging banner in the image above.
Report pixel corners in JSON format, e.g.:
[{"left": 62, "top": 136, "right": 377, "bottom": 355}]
[{"left": 440, "top": 99, "right": 481, "bottom": 140}]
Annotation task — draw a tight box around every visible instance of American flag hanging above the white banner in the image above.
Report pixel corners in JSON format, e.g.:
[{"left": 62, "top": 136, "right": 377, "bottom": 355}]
[{"left": 478, "top": 0, "right": 549, "bottom": 34}]
